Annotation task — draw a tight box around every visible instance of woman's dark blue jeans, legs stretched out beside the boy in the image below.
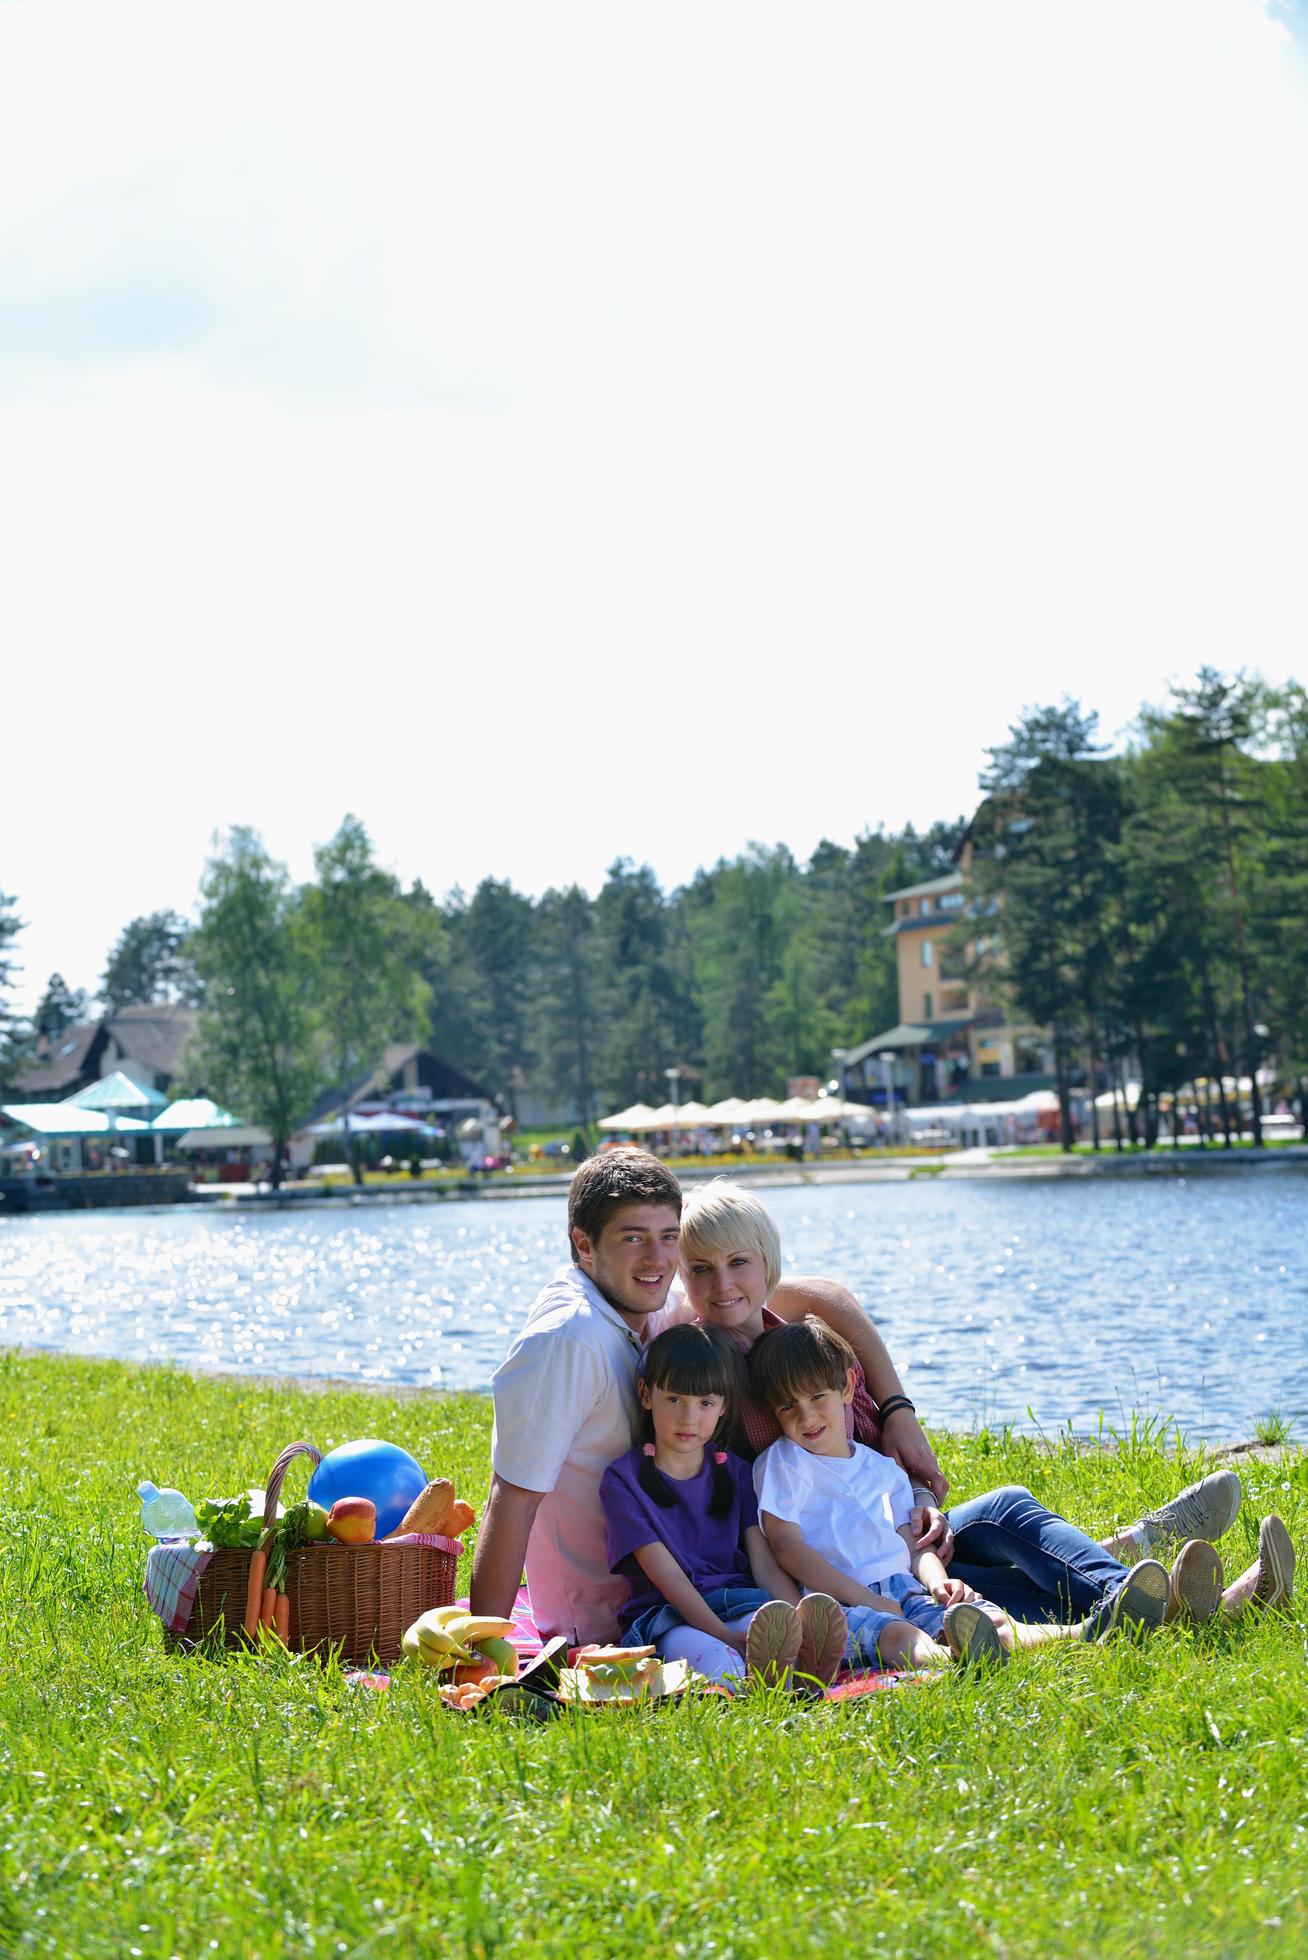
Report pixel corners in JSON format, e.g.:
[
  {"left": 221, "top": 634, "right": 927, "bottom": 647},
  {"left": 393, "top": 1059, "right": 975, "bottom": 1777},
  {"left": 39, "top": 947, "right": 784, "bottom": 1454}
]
[{"left": 945, "top": 1484, "right": 1128, "bottom": 1621}]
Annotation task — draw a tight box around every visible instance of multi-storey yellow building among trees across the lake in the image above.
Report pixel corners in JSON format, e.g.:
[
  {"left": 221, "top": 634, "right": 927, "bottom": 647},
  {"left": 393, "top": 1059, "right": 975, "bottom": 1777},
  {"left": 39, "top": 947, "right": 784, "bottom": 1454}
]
[{"left": 843, "top": 868, "right": 1053, "bottom": 1105}]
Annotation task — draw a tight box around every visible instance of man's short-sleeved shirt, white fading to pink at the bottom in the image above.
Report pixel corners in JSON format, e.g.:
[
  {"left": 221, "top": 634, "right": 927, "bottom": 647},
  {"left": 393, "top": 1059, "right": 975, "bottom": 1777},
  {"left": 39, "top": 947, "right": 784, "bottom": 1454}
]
[{"left": 490, "top": 1266, "right": 686, "bottom": 1644}]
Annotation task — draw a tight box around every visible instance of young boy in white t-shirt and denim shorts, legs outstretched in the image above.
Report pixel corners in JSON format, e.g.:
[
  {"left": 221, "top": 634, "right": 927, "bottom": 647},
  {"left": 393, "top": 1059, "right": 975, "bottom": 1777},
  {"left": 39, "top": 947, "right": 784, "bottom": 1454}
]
[{"left": 749, "top": 1317, "right": 1167, "bottom": 1668}]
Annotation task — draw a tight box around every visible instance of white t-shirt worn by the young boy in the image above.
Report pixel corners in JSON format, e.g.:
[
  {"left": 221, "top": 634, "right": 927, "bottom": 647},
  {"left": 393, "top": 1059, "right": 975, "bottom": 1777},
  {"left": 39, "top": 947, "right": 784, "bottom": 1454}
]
[{"left": 753, "top": 1437, "right": 914, "bottom": 1592}]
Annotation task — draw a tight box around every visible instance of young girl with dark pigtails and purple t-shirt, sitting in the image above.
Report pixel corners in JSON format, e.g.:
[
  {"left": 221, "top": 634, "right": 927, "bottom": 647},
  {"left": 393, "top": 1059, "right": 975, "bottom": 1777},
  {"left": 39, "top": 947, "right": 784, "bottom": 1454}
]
[{"left": 600, "top": 1323, "right": 845, "bottom": 1682}]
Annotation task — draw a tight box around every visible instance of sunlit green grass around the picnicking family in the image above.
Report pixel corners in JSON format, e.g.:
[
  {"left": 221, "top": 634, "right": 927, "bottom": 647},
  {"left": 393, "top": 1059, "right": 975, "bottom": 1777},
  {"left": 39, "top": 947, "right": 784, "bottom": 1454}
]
[{"left": 0, "top": 1354, "right": 1308, "bottom": 1960}]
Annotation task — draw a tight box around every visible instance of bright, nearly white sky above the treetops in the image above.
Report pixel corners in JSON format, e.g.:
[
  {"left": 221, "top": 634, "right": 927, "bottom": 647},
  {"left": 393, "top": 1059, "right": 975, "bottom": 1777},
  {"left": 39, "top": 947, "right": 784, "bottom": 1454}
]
[{"left": 0, "top": 0, "right": 1308, "bottom": 1007}]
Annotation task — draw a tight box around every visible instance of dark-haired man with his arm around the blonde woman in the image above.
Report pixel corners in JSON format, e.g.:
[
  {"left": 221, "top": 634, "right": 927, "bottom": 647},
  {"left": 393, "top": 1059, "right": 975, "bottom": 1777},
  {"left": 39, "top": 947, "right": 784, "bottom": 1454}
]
[{"left": 473, "top": 1149, "right": 947, "bottom": 1644}]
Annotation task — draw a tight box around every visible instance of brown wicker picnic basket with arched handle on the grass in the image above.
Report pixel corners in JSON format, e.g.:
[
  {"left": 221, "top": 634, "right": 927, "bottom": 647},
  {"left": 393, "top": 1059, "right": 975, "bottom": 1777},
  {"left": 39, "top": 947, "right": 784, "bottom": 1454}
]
[{"left": 182, "top": 1443, "right": 463, "bottom": 1664}]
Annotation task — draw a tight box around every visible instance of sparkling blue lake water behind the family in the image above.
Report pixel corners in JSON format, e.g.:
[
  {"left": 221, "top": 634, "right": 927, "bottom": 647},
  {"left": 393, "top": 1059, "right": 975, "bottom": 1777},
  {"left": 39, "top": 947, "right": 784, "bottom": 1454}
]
[{"left": 0, "top": 1168, "right": 1308, "bottom": 1443}]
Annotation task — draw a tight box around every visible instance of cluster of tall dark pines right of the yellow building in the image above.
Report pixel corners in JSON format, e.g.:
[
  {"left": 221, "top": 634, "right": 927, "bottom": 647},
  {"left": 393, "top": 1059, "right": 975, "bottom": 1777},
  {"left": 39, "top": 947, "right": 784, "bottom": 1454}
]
[{"left": 972, "top": 668, "right": 1308, "bottom": 1145}]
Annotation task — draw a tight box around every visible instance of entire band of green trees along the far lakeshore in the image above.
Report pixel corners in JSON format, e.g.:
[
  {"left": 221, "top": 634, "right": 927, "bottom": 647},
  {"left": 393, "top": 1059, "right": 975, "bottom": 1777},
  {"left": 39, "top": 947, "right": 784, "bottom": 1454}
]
[{"left": 0, "top": 670, "right": 1308, "bottom": 1141}]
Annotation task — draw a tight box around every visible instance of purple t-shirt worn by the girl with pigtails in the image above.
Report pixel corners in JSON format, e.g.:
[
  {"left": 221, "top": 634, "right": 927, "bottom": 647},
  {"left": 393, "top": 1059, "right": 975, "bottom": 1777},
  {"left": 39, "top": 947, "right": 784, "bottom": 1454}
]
[{"left": 600, "top": 1450, "right": 759, "bottom": 1627}]
